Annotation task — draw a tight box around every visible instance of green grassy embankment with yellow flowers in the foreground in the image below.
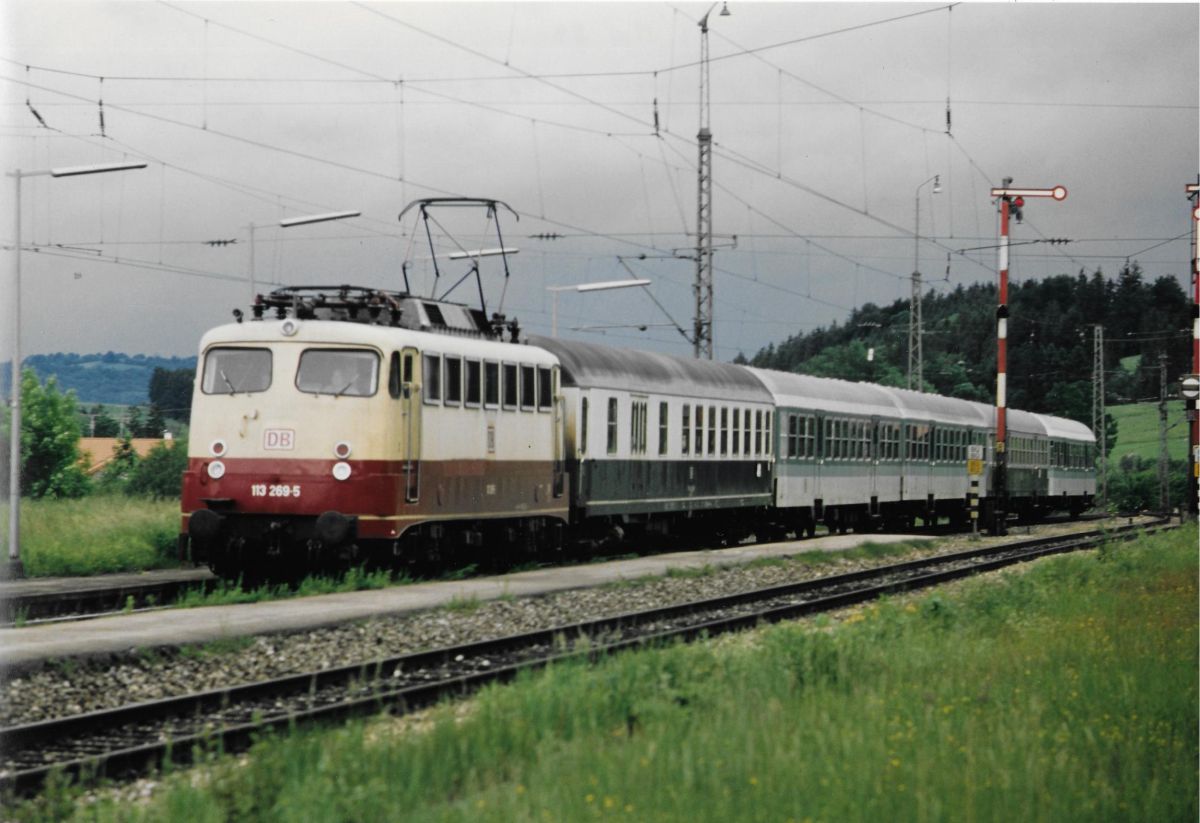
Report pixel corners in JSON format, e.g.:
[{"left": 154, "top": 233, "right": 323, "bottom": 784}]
[{"left": 30, "top": 527, "right": 1198, "bottom": 822}]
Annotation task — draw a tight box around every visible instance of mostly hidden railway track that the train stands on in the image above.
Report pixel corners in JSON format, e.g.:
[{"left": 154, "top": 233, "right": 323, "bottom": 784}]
[{"left": 0, "top": 515, "right": 1104, "bottom": 627}]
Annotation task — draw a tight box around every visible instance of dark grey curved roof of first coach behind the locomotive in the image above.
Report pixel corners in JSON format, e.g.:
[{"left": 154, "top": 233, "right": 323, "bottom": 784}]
[{"left": 529, "top": 337, "right": 772, "bottom": 403}]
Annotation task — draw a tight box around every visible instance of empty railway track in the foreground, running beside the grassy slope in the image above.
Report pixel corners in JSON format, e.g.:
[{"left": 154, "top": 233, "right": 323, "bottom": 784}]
[{"left": 0, "top": 522, "right": 1163, "bottom": 794}]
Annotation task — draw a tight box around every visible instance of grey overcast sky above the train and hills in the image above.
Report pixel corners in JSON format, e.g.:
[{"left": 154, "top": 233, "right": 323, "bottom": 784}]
[{"left": 0, "top": 0, "right": 1200, "bottom": 360}]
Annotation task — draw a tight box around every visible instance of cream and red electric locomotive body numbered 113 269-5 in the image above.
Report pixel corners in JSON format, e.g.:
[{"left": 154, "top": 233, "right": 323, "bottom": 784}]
[{"left": 182, "top": 304, "right": 568, "bottom": 578}]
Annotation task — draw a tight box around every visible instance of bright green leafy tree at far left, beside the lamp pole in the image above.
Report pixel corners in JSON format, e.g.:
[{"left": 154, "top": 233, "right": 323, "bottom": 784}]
[{"left": 20, "top": 368, "right": 90, "bottom": 498}]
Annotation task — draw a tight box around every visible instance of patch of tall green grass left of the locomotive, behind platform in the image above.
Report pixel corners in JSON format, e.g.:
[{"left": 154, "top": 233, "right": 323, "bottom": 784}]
[{"left": 0, "top": 495, "right": 179, "bottom": 577}]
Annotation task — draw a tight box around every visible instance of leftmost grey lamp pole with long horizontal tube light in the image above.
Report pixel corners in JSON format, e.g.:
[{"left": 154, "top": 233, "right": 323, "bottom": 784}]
[{"left": 0, "top": 155, "right": 146, "bottom": 577}]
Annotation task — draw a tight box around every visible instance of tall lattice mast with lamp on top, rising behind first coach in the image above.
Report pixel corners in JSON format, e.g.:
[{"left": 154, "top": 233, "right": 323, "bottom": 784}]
[{"left": 691, "top": 2, "right": 730, "bottom": 360}]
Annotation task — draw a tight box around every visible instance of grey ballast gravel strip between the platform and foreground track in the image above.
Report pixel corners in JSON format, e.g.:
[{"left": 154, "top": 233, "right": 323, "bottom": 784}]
[{"left": 0, "top": 523, "right": 1142, "bottom": 726}]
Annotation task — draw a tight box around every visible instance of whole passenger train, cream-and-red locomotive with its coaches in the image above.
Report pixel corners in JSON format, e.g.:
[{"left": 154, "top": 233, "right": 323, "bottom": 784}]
[{"left": 180, "top": 286, "right": 1096, "bottom": 578}]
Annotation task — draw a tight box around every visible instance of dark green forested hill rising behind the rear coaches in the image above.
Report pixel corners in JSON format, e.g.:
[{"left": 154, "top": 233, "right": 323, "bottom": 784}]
[{"left": 739, "top": 263, "right": 1192, "bottom": 425}]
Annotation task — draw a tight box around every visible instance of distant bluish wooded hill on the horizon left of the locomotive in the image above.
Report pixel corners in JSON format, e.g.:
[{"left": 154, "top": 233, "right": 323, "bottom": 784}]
[{"left": 21, "top": 352, "right": 196, "bottom": 406}]
